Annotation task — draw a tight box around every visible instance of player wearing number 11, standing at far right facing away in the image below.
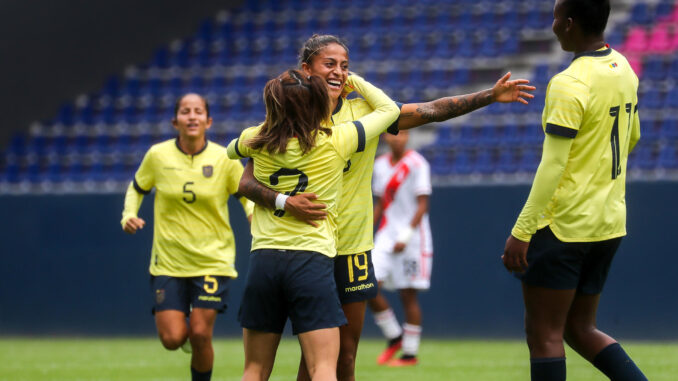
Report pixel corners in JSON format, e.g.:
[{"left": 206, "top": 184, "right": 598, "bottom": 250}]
[{"left": 502, "top": 0, "right": 646, "bottom": 381}]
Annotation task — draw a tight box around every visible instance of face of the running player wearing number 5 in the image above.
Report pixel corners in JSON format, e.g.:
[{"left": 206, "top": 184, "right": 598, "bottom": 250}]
[{"left": 172, "top": 94, "right": 212, "bottom": 140}]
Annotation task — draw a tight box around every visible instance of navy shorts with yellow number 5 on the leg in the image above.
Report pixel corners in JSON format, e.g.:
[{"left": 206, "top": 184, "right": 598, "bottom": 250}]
[{"left": 151, "top": 275, "right": 231, "bottom": 316}]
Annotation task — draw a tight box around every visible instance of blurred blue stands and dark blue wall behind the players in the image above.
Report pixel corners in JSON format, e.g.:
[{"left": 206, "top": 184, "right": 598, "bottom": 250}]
[{"left": 0, "top": 0, "right": 678, "bottom": 339}]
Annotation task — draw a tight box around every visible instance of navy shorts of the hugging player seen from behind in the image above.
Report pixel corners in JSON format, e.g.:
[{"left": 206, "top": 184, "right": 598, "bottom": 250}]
[{"left": 238, "top": 249, "right": 346, "bottom": 335}]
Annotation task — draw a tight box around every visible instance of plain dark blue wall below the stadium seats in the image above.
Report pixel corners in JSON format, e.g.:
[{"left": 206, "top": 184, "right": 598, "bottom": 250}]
[{"left": 0, "top": 183, "right": 678, "bottom": 340}]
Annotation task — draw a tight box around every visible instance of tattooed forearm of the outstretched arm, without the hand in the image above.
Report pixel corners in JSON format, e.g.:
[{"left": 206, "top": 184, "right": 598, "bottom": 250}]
[{"left": 417, "top": 89, "right": 492, "bottom": 122}]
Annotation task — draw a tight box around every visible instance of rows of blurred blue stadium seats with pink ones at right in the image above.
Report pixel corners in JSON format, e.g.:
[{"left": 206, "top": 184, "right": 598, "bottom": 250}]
[{"left": 5, "top": 0, "right": 678, "bottom": 191}]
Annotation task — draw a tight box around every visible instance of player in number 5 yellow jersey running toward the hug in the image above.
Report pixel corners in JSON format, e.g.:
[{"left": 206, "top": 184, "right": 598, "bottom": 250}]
[{"left": 121, "top": 94, "right": 253, "bottom": 380}]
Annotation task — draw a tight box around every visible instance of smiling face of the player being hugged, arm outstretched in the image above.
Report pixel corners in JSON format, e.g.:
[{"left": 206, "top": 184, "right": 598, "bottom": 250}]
[{"left": 301, "top": 43, "right": 348, "bottom": 100}]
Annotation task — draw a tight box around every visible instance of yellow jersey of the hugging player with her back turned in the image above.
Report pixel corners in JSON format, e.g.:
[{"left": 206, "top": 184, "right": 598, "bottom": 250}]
[{"left": 227, "top": 75, "right": 400, "bottom": 257}]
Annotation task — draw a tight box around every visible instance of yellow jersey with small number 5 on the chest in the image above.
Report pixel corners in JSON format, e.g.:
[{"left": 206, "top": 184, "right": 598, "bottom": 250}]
[{"left": 121, "top": 138, "right": 253, "bottom": 278}]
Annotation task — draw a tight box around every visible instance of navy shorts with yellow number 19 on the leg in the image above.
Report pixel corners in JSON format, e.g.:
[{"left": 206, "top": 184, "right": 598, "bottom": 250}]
[{"left": 334, "top": 251, "right": 378, "bottom": 304}]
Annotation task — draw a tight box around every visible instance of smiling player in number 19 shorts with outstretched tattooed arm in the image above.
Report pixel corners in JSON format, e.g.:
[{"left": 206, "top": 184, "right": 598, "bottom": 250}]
[{"left": 239, "top": 35, "right": 534, "bottom": 381}]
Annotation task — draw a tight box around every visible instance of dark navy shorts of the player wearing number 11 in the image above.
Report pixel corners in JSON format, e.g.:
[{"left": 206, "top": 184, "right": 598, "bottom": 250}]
[{"left": 516, "top": 226, "right": 622, "bottom": 295}]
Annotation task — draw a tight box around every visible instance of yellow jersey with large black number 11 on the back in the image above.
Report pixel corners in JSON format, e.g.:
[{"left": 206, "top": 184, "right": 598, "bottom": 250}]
[{"left": 516, "top": 47, "right": 640, "bottom": 242}]
